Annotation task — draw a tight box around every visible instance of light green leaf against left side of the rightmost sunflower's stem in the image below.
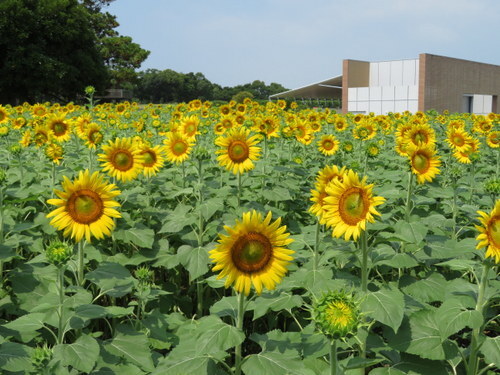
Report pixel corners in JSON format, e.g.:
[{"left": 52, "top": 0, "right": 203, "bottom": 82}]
[{"left": 436, "top": 299, "right": 483, "bottom": 337}]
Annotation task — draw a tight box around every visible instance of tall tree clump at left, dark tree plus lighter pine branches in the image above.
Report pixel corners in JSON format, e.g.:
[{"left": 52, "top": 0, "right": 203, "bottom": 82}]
[{"left": 0, "top": 0, "right": 149, "bottom": 104}]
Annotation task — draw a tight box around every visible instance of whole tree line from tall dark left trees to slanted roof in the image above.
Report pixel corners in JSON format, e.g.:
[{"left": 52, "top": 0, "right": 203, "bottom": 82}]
[{"left": 0, "top": 0, "right": 285, "bottom": 104}]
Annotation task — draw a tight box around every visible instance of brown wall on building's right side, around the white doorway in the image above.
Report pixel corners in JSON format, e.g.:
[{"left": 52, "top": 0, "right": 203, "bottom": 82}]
[{"left": 418, "top": 53, "right": 500, "bottom": 112}]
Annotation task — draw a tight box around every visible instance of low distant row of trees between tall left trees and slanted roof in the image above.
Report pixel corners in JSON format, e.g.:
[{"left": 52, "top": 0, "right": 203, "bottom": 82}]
[{"left": 133, "top": 69, "right": 286, "bottom": 103}]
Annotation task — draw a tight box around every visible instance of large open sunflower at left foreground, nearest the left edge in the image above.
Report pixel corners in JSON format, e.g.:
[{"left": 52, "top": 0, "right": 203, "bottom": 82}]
[{"left": 47, "top": 170, "right": 121, "bottom": 242}]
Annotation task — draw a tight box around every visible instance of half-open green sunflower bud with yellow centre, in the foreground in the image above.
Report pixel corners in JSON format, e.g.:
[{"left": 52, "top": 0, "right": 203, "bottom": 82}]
[{"left": 312, "top": 291, "right": 361, "bottom": 339}]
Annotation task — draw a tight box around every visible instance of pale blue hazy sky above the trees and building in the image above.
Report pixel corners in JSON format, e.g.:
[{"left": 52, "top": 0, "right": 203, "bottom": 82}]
[{"left": 104, "top": 0, "right": 500, "bottom": 89}]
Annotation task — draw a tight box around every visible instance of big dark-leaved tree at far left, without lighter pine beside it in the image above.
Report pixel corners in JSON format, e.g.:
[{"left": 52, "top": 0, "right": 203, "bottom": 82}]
[{"left": 0, "top": 0, "right": 108, "bottom": 103}]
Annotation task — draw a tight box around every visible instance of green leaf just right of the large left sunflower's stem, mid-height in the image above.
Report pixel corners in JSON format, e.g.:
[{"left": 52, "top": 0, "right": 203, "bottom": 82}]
[{"left": 85, "top": 262, "right": 135, "bottom": 297}]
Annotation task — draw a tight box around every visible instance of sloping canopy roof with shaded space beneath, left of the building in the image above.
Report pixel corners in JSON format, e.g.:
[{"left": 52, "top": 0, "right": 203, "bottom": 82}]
[{"left": 269, "top": 75, "right": 342, "bottom": 99}]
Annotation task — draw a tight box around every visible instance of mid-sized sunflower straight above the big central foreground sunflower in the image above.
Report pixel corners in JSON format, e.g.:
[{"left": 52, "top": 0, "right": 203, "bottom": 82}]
[{"left": 215, "top": 128, "right": 260, "bottom": 174}]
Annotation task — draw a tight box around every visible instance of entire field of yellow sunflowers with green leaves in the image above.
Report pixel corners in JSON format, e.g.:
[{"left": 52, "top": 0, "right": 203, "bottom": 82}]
[{"left": 0, "top": 94, "right": 500, "bottom": 375}]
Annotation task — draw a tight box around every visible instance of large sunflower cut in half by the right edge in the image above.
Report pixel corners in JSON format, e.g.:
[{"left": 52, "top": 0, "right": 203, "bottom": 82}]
[{"left": 475, "top": 200, "right": 500, "bottom": 264}]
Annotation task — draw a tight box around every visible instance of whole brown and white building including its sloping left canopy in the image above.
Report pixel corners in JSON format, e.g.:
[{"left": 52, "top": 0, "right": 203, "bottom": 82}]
[{"left": 270, "top": 53, "right": 500, "bottom": 114}]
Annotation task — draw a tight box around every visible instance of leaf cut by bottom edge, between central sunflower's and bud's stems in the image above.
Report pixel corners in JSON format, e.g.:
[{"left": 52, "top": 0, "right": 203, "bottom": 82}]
[{"left": 242, "top": 352, "right": 314, "bottom": 375}]
